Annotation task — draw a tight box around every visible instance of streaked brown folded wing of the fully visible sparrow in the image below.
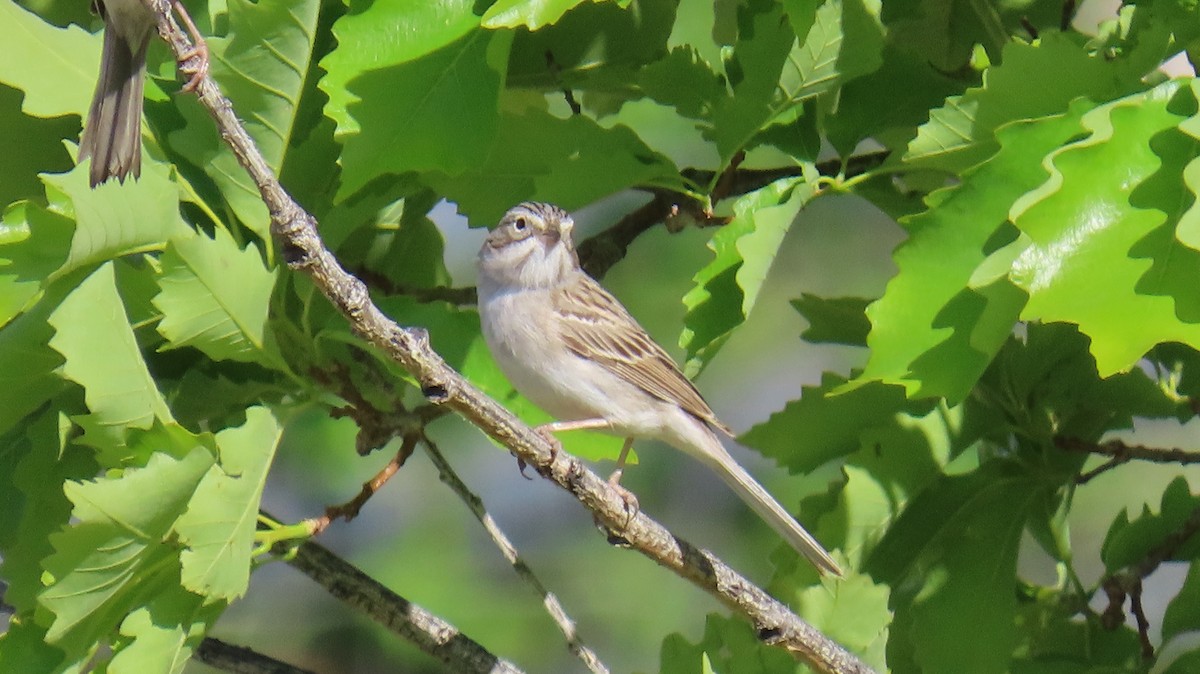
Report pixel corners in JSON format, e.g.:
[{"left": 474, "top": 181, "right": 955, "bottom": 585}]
[{"left": 554, "top": 275, "right": 733, "bottom": 435}]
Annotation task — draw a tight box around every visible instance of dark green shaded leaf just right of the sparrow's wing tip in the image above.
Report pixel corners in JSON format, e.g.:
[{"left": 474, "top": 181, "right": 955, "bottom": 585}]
[{"left": 738, "top": 372, "right": 905, "bottom": 473}]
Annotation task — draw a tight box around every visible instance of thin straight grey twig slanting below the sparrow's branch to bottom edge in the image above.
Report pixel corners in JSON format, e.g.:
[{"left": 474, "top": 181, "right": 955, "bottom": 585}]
[{"left": 424, "top": 438, "right": 608, "bottom": 674}]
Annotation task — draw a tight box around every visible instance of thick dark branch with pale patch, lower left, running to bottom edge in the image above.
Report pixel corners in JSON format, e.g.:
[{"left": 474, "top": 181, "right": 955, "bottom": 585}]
[{"left": 288, "top": 541, "right": 521, "bottom": 674}]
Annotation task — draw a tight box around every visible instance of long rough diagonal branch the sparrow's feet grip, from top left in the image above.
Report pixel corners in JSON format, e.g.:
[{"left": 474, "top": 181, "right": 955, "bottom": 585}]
[{"left": 144, "top": 0, "right": 871, "bottom": 673}]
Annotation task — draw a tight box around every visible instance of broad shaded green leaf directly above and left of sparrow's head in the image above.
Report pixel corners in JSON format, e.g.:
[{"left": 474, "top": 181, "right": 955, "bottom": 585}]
[{"left": 338, "top": 30, "right": 512, "bottom": 198}]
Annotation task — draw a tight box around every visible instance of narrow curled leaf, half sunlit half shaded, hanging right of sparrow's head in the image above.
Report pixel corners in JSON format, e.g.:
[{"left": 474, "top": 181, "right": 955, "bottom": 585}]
[{"left": 679, "top": 177, "right": 816, "bottom": 375}]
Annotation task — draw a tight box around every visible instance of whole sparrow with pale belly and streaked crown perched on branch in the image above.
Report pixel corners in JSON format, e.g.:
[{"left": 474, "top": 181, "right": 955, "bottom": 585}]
[{"left": 479, "top": 203, "right": 841, "bottom": 576}]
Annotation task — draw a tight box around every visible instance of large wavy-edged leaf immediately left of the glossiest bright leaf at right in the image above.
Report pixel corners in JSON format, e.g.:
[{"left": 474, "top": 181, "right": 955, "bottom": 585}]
[{"left": 858, "top": 102, "right": 1087, "bottom": 402}]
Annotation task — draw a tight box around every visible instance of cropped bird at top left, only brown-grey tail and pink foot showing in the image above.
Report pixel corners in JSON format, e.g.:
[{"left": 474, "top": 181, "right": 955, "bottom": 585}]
[{"left": 79, "top": 0, "right": 209, "bottom": 187}]
